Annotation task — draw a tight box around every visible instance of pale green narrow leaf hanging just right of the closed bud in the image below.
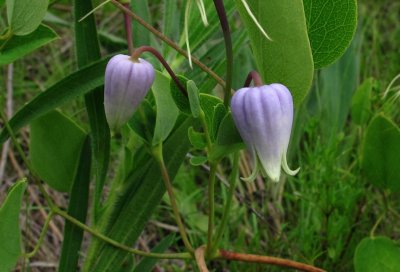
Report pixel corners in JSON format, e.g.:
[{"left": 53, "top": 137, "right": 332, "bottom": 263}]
[{"left": 151, "top": 71, "right": 179, "bottom": 146}]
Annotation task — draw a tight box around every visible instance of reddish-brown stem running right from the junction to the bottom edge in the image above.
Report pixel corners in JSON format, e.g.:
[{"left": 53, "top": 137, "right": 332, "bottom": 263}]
[{"left": 218, "top": 249, "right": 325, "bottom": 272}]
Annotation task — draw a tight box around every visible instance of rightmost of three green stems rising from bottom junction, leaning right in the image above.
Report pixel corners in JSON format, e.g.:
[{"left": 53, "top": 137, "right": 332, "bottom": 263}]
[{"left": 211, "top": 152, "right": 239, "bottom": 256}]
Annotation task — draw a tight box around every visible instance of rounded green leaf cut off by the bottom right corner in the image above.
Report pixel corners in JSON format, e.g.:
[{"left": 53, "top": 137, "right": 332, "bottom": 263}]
[{"left": 354, "top": 237, "right": 400, "bottom": 272}]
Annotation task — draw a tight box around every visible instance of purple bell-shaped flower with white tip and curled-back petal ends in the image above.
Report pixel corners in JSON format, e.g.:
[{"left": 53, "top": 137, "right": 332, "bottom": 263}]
[{"left": 231, "top": 83, "right": 299, "bottom": 181}]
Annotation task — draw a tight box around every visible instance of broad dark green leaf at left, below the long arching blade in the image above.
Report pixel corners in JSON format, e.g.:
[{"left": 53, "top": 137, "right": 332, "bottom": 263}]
[{"left": 29, "top": 111, "right": 86, "bottom": 192}]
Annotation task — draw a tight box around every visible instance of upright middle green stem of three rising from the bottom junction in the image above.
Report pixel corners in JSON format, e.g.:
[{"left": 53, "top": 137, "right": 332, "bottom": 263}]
[{"left": 207, "top": 163, "right": 217, "bottom": 258}]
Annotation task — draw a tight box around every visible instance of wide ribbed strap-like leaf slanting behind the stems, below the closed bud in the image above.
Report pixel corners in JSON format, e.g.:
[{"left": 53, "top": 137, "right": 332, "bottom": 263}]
[{"left": 83, "top": 118, "right": 193, "bottom": 272}]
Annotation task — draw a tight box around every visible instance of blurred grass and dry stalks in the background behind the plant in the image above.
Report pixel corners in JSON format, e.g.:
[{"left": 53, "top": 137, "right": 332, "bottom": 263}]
[{"left": 0, "top": 0, "right": 400, "bottom": 271}]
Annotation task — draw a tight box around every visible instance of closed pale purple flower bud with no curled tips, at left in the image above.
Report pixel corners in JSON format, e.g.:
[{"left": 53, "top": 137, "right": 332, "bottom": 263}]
[{"left": 104, "top": 54, "right": 154, "bottom": 129}]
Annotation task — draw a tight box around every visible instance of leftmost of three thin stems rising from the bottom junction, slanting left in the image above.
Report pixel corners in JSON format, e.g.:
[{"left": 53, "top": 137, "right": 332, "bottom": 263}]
[{"left": 153, "top": 144, "right": 194, "bottom": 253}]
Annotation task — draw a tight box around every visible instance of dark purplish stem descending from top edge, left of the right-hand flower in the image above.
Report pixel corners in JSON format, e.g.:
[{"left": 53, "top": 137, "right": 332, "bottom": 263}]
[{"left": 214, "top": 0, "right": 233, "bottom": 107}]
